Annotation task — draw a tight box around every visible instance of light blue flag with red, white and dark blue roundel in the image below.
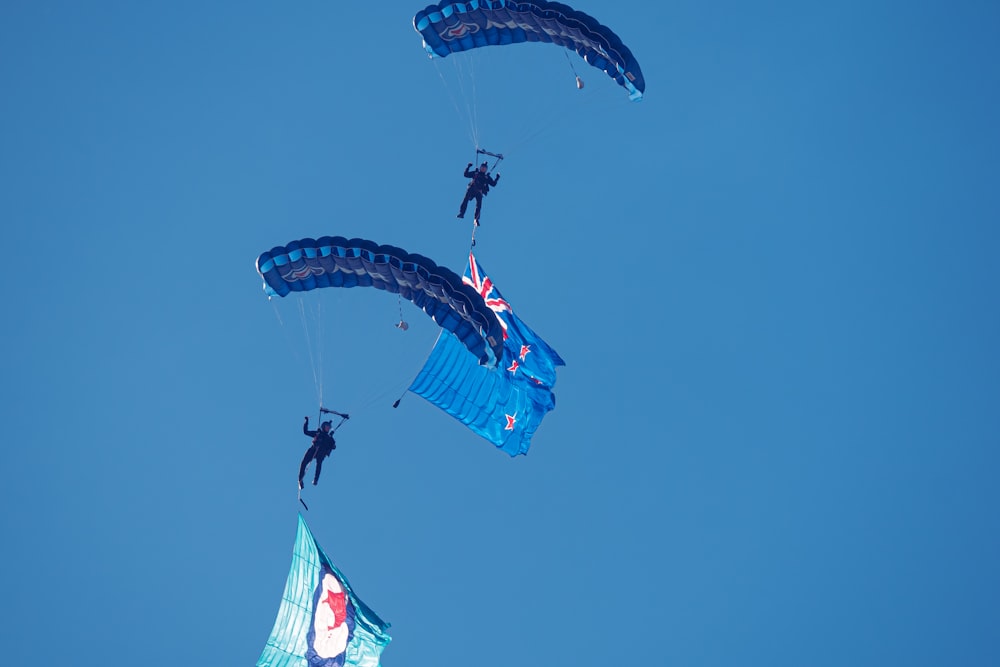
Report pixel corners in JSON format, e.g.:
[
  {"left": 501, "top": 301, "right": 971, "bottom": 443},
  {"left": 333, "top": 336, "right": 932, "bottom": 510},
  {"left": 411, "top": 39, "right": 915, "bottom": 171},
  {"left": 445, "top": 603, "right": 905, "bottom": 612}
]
[{"left": 257, "top": 516, "right": 390, "bottom": 667}]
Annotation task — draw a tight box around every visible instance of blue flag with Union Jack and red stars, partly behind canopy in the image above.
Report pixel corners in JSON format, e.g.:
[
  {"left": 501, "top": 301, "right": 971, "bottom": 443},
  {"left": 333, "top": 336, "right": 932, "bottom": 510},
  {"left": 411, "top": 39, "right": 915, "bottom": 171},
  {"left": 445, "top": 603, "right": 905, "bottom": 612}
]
[{"left": 410, "top": 253, "right": 565, "bottom": 456}]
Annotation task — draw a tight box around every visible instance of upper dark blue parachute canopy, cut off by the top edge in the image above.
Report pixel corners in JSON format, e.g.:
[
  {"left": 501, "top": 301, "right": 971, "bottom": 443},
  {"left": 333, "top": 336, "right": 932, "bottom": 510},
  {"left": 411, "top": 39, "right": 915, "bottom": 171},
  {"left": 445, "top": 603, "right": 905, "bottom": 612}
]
[{"left": 413, "top": 0, "right": 646, "bottom": 100}]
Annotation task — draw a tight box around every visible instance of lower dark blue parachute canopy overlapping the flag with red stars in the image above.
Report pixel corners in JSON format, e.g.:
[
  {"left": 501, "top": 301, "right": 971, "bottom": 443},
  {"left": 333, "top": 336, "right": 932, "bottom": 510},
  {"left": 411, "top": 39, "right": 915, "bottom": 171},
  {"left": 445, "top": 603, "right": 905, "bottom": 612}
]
[{"left": 257, "top": 236, "right": 503, "bottom": 365}]
